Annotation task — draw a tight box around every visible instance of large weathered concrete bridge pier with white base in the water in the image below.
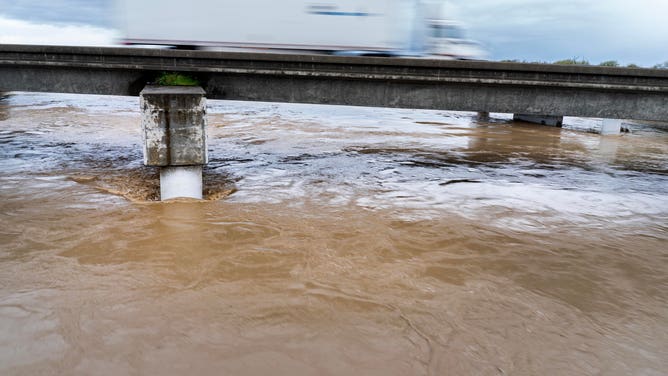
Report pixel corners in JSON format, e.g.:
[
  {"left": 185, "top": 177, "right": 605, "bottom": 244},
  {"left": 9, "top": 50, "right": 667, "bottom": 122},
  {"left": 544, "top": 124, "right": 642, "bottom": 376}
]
[{"left": 140, "top": 85, "right": 208, "bottom": 200}]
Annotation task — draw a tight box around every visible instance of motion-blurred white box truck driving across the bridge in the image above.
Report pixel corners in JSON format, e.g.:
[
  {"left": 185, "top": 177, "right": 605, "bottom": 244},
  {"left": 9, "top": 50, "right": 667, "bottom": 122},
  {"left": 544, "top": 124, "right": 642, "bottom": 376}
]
[{"left": 115, "top": 0, "right": 484, "bottom": 59}]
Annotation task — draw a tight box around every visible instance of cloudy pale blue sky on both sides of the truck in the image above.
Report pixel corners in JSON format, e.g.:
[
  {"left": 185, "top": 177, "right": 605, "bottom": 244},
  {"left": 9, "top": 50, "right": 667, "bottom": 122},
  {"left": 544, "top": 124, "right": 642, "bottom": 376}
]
[{"left": 0, "top": 0, "right": 668, "bottom": 66}]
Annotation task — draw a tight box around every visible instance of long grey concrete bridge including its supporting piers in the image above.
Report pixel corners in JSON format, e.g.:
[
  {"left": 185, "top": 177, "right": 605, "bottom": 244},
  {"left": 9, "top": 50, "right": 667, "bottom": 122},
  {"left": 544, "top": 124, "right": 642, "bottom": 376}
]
[{"left": 0, "top": 45, "right": 668, "bottom": 199}]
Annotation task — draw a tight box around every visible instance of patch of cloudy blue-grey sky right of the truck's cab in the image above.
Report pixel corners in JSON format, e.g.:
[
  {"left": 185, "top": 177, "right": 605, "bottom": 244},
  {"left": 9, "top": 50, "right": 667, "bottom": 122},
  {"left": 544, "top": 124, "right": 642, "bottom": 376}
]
[{"left": 457, "top": 0, "right": 668, "bottom": 66}]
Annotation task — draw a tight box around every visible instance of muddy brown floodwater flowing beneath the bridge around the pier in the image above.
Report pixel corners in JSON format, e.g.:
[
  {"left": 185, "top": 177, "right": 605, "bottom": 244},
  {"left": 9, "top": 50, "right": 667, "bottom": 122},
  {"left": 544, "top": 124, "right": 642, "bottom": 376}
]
[{"left": 0, "top": 93, "right": 668, "bottom": 375}]
